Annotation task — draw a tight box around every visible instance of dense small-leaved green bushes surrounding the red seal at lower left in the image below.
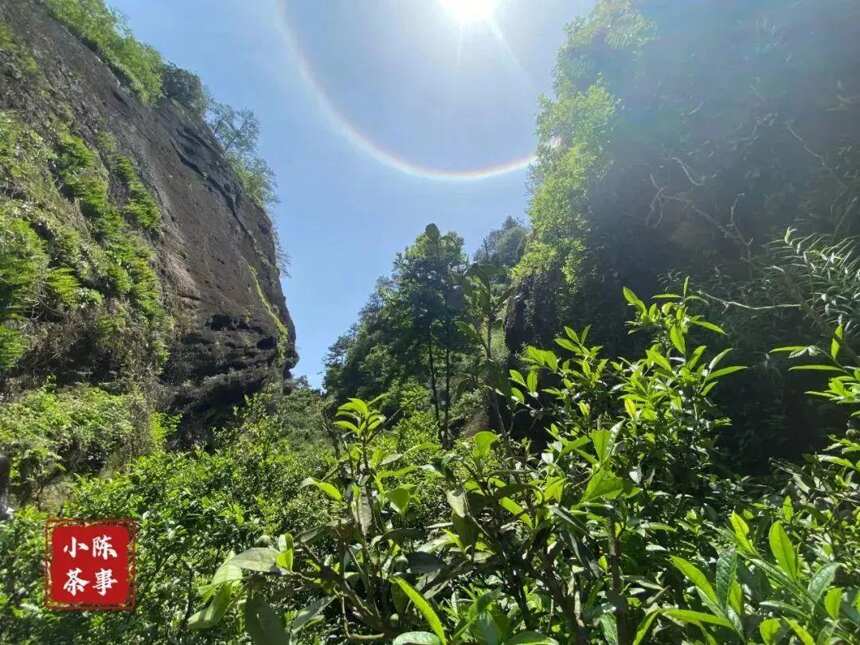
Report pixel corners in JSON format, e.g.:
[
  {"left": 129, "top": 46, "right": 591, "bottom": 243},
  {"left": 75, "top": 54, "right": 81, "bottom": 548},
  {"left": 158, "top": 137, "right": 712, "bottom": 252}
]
[{"left": 0, "top": 390, "right": 329, "bottom": 644}]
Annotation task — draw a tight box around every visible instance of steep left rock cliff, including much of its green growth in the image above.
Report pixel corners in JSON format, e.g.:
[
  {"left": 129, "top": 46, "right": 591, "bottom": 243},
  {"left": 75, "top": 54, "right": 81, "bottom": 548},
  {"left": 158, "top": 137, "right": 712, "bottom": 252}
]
[{"left": 0, "top": 0, "right": 297, "bottom": 428}]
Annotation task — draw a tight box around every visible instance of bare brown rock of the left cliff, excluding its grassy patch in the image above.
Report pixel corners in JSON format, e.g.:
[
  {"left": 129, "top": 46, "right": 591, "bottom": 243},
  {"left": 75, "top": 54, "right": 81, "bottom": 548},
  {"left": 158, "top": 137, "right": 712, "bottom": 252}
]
[{"left": 0, "top": 0, "right": 297, "bottom": 427}]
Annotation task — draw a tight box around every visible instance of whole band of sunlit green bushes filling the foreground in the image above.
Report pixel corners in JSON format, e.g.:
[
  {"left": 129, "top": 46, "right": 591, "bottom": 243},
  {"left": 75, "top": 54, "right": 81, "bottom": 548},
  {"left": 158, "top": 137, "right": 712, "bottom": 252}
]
[{"left": 0, "top": 284, "right": 860, "bottom": 643}]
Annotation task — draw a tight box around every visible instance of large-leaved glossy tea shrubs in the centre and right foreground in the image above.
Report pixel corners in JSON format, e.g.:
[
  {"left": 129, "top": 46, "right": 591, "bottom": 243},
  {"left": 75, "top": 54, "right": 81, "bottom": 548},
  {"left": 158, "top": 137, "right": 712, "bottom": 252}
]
[{"left": 190, "top": 287, "right": 860, "bottom": 643}]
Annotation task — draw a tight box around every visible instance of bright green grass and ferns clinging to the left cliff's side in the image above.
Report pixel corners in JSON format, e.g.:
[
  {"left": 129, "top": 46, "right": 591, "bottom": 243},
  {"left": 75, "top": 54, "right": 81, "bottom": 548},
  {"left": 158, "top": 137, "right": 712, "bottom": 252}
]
[{"left": 0, "top": 112, "right": 171, "bottom": 373}]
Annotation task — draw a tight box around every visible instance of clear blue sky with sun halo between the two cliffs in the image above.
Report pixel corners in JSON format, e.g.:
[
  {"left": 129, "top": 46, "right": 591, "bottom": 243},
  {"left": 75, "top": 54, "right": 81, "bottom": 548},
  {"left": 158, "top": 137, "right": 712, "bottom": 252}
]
[{"left": 109, "top": 0, "right": 591, "bottom": 384}]
